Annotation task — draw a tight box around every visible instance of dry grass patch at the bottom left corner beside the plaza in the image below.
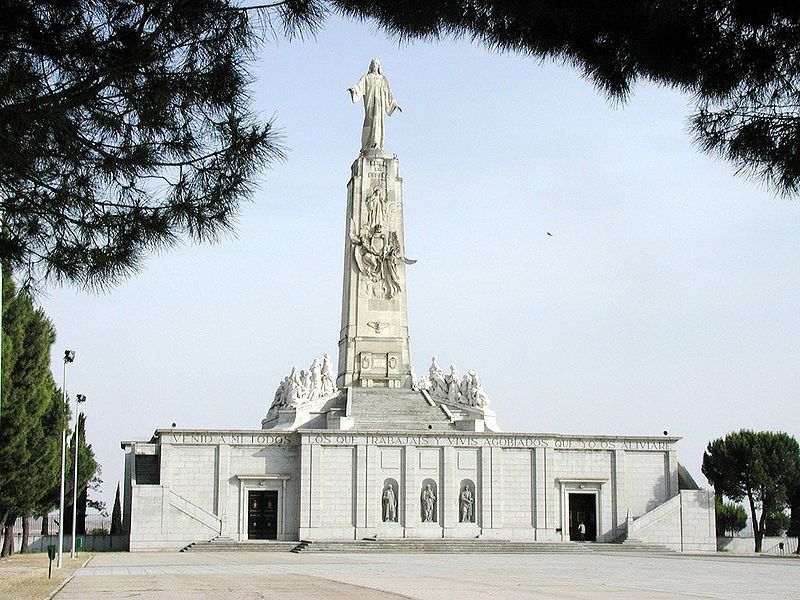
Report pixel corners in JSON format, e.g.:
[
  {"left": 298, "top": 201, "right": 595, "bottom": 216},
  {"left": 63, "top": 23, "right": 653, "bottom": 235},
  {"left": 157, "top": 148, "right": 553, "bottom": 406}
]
[{"left": 0, "top": 552, "right": 91, "bottom": 600}]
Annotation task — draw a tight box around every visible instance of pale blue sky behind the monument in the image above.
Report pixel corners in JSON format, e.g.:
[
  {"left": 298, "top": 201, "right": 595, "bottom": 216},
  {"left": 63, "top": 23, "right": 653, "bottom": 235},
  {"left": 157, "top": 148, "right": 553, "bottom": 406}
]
[{"left": 41, "top": 18, "right": 800, "bottom": 506}]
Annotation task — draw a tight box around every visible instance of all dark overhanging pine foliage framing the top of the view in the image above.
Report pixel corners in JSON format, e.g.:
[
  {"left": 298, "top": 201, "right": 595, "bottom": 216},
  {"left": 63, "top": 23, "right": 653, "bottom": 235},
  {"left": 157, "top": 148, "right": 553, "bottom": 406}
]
[{"left": 0, "top": 0, "right": 800, "bottom": 287}]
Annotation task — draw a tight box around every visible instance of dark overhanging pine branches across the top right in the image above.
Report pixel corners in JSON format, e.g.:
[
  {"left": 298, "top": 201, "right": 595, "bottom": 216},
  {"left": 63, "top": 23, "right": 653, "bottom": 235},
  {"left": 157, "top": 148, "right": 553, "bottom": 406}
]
[{"left": 324, "top": 0, "right": 800, "bottom": 194}]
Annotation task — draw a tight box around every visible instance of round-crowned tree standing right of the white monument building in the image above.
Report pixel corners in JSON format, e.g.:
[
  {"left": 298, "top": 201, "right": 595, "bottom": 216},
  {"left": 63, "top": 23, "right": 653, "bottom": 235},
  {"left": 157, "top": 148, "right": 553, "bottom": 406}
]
[{"left": 703, "top": 429, "right": 800, "bottom": 552}]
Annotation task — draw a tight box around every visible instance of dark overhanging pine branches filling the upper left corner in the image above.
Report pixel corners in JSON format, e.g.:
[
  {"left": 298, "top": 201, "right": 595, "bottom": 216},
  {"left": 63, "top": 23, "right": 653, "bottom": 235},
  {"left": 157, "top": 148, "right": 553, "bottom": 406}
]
[{"left": 0, "top": 0, "right": 286, "bottom": 287}]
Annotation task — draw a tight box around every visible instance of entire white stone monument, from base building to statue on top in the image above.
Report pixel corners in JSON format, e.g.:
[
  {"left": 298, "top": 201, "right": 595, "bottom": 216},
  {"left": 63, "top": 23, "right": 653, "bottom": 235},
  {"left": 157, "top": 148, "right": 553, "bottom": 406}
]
[{"left": 122, "top": 61, "right": 716, "bottom": 551}]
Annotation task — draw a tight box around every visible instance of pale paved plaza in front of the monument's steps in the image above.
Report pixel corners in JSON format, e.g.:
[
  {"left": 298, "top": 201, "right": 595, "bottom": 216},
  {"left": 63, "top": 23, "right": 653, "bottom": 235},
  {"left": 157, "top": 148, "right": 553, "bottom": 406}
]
[{"left": 55, "top": 552, "right": 800, "bottom": 600}]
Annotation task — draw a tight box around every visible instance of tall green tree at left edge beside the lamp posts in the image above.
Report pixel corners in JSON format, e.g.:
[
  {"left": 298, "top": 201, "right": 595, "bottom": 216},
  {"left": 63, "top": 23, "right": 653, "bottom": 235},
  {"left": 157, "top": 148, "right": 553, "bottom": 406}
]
[{"left": 0, "top": 277, "right": 67, "bottom": 555}]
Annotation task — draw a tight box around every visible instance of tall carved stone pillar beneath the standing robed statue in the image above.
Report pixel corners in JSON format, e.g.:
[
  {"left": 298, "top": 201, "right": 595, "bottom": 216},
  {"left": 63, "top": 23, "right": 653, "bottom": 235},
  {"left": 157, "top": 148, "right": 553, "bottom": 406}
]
[{"left": 336, "top": 150, "right": 412, "bottom": 388}]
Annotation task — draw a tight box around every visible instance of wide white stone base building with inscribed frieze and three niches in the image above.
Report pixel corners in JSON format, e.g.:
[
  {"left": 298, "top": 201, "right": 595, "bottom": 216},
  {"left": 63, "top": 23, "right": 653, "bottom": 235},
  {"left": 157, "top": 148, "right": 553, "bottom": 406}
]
[{"left": 123, "top": 430, "right": 715, "bottom": 551}]
